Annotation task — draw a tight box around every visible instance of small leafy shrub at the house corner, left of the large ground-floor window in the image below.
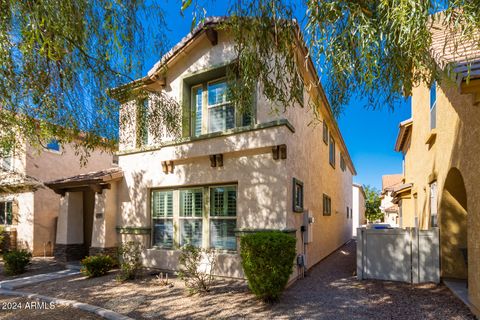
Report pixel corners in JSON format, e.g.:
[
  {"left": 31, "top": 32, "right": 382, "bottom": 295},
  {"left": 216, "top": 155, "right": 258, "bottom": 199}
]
[{"left": 117, "top": 241, "right": 143, "bottom": 281}]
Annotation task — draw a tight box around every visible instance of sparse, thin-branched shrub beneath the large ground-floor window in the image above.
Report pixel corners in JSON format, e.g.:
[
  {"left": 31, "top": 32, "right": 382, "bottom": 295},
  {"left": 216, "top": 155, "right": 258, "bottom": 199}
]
[{"left": 178, "top": 244, "right": 217, "bottom": 294}]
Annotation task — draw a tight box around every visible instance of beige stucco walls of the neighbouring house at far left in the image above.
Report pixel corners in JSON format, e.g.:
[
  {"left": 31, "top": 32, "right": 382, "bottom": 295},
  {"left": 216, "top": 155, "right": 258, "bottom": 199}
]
[{"left": 0, "top": 144, "right": 112, "bottom": 255}]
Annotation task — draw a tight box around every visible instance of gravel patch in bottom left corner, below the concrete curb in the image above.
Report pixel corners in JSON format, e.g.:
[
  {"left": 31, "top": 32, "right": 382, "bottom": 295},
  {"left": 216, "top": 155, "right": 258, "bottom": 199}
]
[{"left": 0, "top": 296, "right": 102, "bottom": 320}]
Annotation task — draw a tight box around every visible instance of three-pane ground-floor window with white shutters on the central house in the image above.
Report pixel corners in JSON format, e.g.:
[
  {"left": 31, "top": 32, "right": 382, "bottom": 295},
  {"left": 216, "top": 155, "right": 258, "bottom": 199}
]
[{"left": 151, "top": 185, "right": 237, "bottom": 251}]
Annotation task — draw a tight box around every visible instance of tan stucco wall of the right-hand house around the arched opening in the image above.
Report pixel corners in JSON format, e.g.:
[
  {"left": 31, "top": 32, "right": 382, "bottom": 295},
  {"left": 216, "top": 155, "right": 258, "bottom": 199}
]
[{"left": 403, "top": 81, "right": 480, "bottom": 312}]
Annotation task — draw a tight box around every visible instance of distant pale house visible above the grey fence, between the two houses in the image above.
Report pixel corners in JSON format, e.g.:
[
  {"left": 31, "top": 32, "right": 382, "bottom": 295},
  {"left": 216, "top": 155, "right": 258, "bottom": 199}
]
[{"left": 380, "top": 174, "right": 403, "bottom": 227}]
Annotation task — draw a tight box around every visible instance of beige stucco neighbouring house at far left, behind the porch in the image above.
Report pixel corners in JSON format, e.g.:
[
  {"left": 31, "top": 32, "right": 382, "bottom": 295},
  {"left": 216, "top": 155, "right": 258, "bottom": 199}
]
[{"left": 0, "top": 140, "right": 112, "bottom": 256}]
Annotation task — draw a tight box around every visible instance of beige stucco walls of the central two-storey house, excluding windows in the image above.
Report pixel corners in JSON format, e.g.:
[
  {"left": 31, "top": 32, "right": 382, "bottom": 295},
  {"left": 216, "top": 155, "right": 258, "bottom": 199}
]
[{"left": 117, "top": 27, "right": 352, "bottom": 277}]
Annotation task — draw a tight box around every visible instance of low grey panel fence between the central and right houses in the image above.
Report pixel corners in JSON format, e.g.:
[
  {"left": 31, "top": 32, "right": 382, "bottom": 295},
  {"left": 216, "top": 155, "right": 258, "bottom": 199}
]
[{"left": 357, "top": 228, "right": 440, "bottom": 283}]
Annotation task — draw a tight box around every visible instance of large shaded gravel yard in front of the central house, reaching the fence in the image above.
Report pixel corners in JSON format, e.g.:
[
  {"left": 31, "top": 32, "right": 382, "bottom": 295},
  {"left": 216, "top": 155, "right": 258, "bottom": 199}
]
[{"left": 15, "top": 242, "right": 474, "bottom": 320}]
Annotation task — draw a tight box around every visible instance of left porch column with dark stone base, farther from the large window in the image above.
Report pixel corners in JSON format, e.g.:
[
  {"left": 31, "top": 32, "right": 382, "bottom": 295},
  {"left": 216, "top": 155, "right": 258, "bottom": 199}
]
[{"left": 54, "top": 192, "right": 85, "bottom": 262}]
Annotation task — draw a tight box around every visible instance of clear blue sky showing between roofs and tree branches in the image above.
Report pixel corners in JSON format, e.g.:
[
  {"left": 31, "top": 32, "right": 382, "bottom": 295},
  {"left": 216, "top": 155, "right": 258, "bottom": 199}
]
[{"left": 156, "top": 0, "right": 410, "bottom": 189}]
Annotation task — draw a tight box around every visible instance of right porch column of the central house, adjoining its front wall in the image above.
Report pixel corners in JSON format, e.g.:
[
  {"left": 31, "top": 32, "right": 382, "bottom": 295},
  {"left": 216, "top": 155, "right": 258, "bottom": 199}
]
[{"left": 89, "top": 182, "right": 117, "bottom": 256}]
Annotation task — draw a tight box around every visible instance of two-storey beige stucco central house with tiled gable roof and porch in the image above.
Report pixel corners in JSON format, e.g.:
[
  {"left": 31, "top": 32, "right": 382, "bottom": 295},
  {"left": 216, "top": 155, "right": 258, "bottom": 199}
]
[{"left": 49, "top": 18, "right": 355, "bottom": 277}]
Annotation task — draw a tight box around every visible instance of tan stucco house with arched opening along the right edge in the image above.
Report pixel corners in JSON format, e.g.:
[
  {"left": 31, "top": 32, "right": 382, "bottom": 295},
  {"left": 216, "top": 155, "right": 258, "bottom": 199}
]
[{"left": 394, "top": 18, "right": 480, "bottom": 316}]
